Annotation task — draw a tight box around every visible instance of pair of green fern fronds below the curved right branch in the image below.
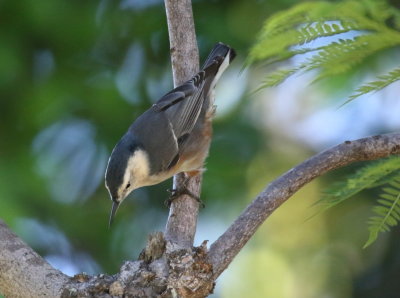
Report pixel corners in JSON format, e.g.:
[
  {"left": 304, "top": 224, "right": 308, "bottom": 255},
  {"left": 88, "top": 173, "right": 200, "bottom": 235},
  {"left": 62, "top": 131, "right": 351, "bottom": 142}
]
[{"left": 318, "top": 156, "right": 400, "bottom": 247}]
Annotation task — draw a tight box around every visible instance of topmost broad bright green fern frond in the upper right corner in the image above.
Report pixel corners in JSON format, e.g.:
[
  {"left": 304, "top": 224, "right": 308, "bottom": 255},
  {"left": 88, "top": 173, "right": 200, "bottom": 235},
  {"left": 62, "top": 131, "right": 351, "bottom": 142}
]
[{"left": 249, "top": 0, "right": 396, "bottom": 62}]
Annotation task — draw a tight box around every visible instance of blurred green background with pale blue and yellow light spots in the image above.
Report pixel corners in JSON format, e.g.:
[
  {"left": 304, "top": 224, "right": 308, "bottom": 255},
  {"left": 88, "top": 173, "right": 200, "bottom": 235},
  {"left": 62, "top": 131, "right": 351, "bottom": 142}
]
[{"left": 0, "top": 0, "right": 400, "bottom": 298}]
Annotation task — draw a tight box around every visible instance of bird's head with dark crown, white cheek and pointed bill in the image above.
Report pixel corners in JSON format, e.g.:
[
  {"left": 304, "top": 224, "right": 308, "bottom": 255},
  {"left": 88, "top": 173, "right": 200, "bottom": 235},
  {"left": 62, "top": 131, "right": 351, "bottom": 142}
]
[{"left": 105, "top": 134, "right": 149, "bottom": 226}]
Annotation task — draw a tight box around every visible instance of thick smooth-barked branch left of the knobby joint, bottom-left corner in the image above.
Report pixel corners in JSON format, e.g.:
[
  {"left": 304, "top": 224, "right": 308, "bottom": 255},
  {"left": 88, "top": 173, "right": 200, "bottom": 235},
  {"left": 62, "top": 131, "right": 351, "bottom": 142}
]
[{"left": 0, "top": 220, "right": 69, "bottom": 297}]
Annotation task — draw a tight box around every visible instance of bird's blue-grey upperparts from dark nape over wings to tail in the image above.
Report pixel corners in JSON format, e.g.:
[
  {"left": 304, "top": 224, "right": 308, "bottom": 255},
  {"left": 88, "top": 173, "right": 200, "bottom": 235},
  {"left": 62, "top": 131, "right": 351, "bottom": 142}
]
[{"left": 106, "top": 43, "right": 235, "bottom": 183}]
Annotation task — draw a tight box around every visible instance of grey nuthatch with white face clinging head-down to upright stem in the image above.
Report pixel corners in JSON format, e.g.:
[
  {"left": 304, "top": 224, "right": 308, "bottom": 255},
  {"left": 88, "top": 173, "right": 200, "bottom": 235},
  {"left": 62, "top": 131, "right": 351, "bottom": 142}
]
[{"left": 105, "top": 42, "right": 236, "bottom": 226}]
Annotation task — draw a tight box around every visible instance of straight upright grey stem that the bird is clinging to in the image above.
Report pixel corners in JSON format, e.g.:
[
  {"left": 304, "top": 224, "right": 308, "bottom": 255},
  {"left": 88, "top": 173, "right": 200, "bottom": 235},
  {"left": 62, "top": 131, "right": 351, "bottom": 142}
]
[{"left": 165, "top": 0, "right": 202, "bottom": 249}]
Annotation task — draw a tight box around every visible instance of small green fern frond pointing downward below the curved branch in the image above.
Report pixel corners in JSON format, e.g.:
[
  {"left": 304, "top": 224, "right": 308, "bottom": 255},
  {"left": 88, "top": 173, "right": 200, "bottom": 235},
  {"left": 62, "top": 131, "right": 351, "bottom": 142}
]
[{"left": 364, "top": 179, "right": 400, "bottom": 248}]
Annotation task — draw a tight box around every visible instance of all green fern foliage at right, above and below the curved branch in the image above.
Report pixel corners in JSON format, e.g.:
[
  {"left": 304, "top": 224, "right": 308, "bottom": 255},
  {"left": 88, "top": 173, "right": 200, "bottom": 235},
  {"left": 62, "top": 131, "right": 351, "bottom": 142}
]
[{"left": 247, "top": 0, "right": 400, "bottom": 246}]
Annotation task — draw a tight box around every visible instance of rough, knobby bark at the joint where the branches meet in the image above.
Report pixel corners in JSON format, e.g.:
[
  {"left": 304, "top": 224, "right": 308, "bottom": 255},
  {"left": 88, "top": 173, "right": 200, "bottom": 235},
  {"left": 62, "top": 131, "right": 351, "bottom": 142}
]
[{"left": 61, "top": 232, "right": 214, "bottom": 298}]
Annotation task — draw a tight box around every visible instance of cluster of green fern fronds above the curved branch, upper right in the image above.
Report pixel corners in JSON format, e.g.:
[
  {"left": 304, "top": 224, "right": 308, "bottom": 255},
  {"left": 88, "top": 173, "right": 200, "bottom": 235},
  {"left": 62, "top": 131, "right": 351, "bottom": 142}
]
[{"left": 247, "top": 0, "right": 400, "bottom": 100}]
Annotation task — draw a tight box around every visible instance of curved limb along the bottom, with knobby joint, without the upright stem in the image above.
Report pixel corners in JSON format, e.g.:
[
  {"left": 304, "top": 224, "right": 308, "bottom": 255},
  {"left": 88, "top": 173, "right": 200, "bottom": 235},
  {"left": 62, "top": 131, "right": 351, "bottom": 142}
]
[{"left": 0, "top": 133, "right": 400, "bottom": 297}]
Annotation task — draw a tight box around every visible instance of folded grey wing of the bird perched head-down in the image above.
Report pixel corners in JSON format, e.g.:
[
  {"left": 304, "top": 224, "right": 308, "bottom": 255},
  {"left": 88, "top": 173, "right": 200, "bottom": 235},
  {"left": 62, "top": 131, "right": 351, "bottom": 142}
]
[{"left": 130, "top": 71, "right": 204, "bottom": 174}]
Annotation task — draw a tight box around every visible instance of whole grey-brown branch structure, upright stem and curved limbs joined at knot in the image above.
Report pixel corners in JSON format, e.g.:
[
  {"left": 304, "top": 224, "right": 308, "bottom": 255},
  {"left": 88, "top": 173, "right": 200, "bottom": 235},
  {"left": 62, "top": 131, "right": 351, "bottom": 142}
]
[{"left": 0, "top": 0, "right": 400, "bottom": 297}]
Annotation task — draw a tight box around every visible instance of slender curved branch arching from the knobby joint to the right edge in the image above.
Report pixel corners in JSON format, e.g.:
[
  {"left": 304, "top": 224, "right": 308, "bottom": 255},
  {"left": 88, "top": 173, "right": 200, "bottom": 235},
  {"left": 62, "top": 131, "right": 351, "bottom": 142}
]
[{"left": 208, "top": 133, "right": 400, "bottom": 278}]
